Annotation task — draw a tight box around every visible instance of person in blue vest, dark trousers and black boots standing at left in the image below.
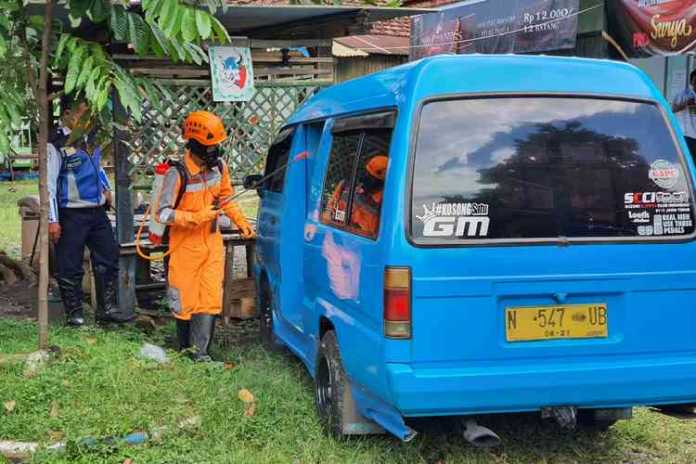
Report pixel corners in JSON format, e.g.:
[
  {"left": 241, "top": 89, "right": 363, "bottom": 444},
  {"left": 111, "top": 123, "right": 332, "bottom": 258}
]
[{"left": 48, "top": 97, "right": 135, "bottom": 327}]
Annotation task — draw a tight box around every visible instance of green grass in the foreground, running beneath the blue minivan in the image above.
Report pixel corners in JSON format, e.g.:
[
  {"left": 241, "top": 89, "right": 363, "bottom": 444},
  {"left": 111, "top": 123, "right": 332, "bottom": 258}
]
[{"left": 0, "top": 320, "right": 696, "bottom": 464}]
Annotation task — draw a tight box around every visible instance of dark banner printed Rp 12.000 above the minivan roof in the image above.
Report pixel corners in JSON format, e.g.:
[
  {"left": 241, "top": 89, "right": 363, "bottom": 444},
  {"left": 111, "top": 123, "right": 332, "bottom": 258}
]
[{"left": 411, "top": 0, "right": 580, "bottom": 60}]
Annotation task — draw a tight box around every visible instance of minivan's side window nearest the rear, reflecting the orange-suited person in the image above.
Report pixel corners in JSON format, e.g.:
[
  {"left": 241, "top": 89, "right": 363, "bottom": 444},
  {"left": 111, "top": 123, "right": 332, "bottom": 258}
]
[{"left": 321, "top": 129, "right": 391, "bottom": 239}]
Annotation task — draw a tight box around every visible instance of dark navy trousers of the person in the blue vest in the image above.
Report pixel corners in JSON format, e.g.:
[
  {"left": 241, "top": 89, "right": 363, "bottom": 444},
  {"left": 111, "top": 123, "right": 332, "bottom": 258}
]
[{"left": 55, "top": 207, "right": 118, "bottom": 282}]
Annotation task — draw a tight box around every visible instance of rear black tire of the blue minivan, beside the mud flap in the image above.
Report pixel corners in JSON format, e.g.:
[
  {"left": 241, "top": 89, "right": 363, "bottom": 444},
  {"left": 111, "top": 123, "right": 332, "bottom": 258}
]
[{"left": 314, "top": 331, "right": 349, "bottom": 439}]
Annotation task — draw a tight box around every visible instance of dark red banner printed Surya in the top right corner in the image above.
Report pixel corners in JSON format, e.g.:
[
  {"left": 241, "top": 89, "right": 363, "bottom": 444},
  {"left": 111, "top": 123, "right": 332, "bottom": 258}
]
[{"left": 606, "top": 0, "right": 696, "bottom": 57}]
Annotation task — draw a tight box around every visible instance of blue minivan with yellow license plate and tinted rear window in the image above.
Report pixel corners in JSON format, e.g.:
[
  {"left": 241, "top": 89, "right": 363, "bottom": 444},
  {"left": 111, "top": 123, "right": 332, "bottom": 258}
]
[{"left": 245, "top": 55, "right": 696, "bottom": 440}]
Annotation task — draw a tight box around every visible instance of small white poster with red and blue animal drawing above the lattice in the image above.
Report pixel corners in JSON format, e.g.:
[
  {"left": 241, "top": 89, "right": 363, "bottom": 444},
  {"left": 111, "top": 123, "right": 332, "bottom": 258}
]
[{"left": 208, "top": 47, "right": 254, "bottom": 101}]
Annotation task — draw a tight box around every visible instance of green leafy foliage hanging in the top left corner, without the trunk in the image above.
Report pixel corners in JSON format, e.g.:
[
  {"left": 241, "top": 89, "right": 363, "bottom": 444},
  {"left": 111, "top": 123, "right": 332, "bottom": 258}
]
[{"left": 0, "top": 0, "right": 230, "bottom": 142}]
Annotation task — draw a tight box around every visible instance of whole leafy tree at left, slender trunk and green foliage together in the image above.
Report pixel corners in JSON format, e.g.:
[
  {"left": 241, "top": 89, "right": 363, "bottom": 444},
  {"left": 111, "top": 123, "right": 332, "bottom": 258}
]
[{"left": 0, "top": 0, "right": 230, "bottom": 347}]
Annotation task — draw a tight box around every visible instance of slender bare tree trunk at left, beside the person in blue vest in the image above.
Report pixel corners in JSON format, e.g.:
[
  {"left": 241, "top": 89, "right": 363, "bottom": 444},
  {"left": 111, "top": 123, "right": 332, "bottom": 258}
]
[{"left": 34, "top": 0, "right": 53, "bottom": 350}]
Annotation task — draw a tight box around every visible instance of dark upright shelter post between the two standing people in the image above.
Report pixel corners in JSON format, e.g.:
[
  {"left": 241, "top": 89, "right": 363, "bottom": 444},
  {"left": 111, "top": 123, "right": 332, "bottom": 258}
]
[{"left": 113, "top": 92, "right": 136, "bottom": 312}]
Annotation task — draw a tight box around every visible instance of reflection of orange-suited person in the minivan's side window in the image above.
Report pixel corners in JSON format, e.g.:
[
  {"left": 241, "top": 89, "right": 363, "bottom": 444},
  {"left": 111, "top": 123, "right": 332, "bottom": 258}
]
[{"left": 326, "top": 155, "right": 389, "bottom": 238}]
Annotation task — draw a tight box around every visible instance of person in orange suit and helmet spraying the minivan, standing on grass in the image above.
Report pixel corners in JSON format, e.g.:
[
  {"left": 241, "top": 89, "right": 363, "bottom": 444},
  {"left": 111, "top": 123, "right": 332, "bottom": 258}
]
[{"left": 156, "top": 111, "right": 254, "bottom": 361}]
